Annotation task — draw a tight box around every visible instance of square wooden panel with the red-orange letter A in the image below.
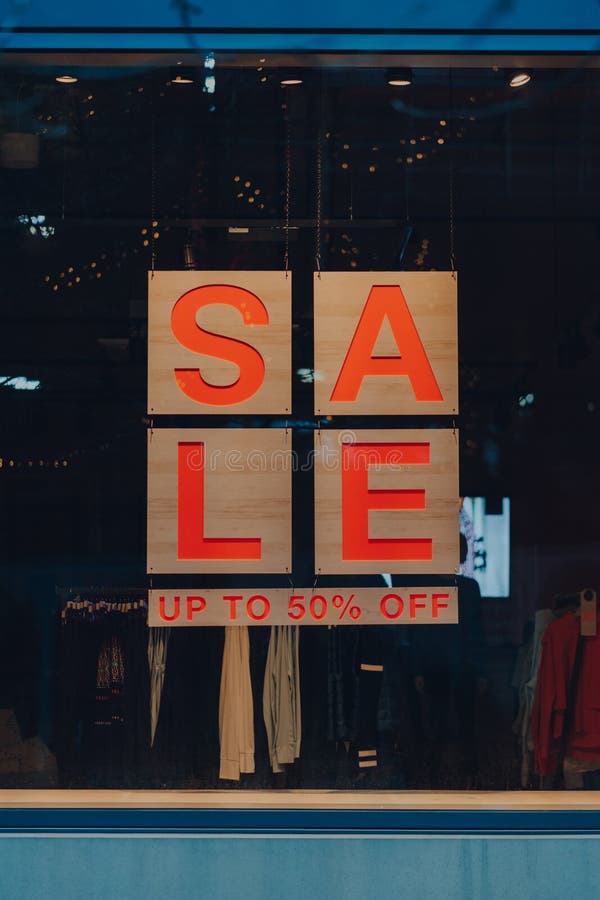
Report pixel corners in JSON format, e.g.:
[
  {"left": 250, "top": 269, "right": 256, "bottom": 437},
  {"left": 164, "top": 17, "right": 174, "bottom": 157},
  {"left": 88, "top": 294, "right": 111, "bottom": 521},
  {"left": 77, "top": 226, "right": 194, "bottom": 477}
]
[{"left": 314, "top": 272, "right": 458, "bottom": 416}]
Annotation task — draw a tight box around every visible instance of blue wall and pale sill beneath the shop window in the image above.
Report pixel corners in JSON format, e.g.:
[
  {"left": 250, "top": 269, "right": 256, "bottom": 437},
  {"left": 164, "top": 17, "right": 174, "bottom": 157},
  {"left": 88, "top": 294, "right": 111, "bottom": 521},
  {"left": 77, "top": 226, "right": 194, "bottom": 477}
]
[{"left": 0, "top": 792, "right": 600, "bottom": 900}]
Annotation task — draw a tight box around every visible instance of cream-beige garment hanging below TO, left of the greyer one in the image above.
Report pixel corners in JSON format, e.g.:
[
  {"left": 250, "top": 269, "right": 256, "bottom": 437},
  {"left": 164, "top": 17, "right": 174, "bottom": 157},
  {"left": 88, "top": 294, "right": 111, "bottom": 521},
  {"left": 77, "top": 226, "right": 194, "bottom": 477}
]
[{"left": 219, "top": 625, "right": 254, "bottom": 781}]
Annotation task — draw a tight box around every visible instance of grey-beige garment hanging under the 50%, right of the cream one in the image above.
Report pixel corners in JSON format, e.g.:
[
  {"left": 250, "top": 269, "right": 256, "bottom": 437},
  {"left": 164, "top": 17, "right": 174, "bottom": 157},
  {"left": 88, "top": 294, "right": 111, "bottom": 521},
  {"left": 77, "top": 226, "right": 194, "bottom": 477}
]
[{"left": 263, "top": 625, "right": 302, "bottom": 772}]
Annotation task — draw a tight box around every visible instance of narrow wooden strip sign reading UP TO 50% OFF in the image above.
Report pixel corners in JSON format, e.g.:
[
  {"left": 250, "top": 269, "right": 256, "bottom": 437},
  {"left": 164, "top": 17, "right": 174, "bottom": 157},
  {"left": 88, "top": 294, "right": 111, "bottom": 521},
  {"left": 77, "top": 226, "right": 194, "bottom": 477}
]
[{"left": 148, "top": 587, "right": 458, "bottom": 627}]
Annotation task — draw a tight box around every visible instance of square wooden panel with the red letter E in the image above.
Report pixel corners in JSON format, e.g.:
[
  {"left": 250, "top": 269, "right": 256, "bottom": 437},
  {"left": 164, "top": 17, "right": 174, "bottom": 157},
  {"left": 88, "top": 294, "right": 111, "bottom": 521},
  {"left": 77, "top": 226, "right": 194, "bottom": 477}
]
[{"left": 315, "top": 429, "right": 459, "bottom": 575}]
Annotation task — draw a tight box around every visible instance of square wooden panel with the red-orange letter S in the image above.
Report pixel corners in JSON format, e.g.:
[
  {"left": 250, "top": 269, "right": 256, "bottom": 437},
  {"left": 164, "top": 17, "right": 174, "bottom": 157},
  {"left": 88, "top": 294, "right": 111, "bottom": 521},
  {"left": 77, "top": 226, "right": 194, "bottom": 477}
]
[{"left": 148, "top": 272, "right": 292, "bottom": 415}]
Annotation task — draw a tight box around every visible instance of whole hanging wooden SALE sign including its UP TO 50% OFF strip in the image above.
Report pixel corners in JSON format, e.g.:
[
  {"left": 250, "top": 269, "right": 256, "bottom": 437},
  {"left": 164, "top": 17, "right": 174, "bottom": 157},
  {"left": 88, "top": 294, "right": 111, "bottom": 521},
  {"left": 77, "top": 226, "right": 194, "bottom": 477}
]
[{"left": 147, "top": 271, "right": 459, "bottom": 626}]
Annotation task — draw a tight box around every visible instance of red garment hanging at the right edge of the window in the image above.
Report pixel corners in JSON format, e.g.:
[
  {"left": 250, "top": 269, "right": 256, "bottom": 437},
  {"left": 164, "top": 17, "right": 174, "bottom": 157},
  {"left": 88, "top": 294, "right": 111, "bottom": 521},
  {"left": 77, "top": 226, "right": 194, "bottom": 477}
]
[{"left": 531, "top": 612, "right": 600, "bottom": 775}]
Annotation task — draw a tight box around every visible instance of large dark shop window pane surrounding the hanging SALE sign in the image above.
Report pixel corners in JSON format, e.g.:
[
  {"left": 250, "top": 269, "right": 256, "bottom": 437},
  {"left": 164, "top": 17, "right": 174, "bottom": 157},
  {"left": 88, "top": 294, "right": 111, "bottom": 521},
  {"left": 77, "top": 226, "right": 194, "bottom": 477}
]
[{"left": 0, "top": 54, "right": 600, "bottom": 790}]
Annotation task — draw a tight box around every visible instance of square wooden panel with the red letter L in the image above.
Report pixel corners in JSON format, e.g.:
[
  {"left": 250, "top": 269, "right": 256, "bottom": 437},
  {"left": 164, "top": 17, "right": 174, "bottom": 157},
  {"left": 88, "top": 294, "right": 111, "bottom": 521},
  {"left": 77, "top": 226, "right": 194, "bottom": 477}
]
[{"left": 147, "top": 428, "right": 292, "bottom": 574}]
